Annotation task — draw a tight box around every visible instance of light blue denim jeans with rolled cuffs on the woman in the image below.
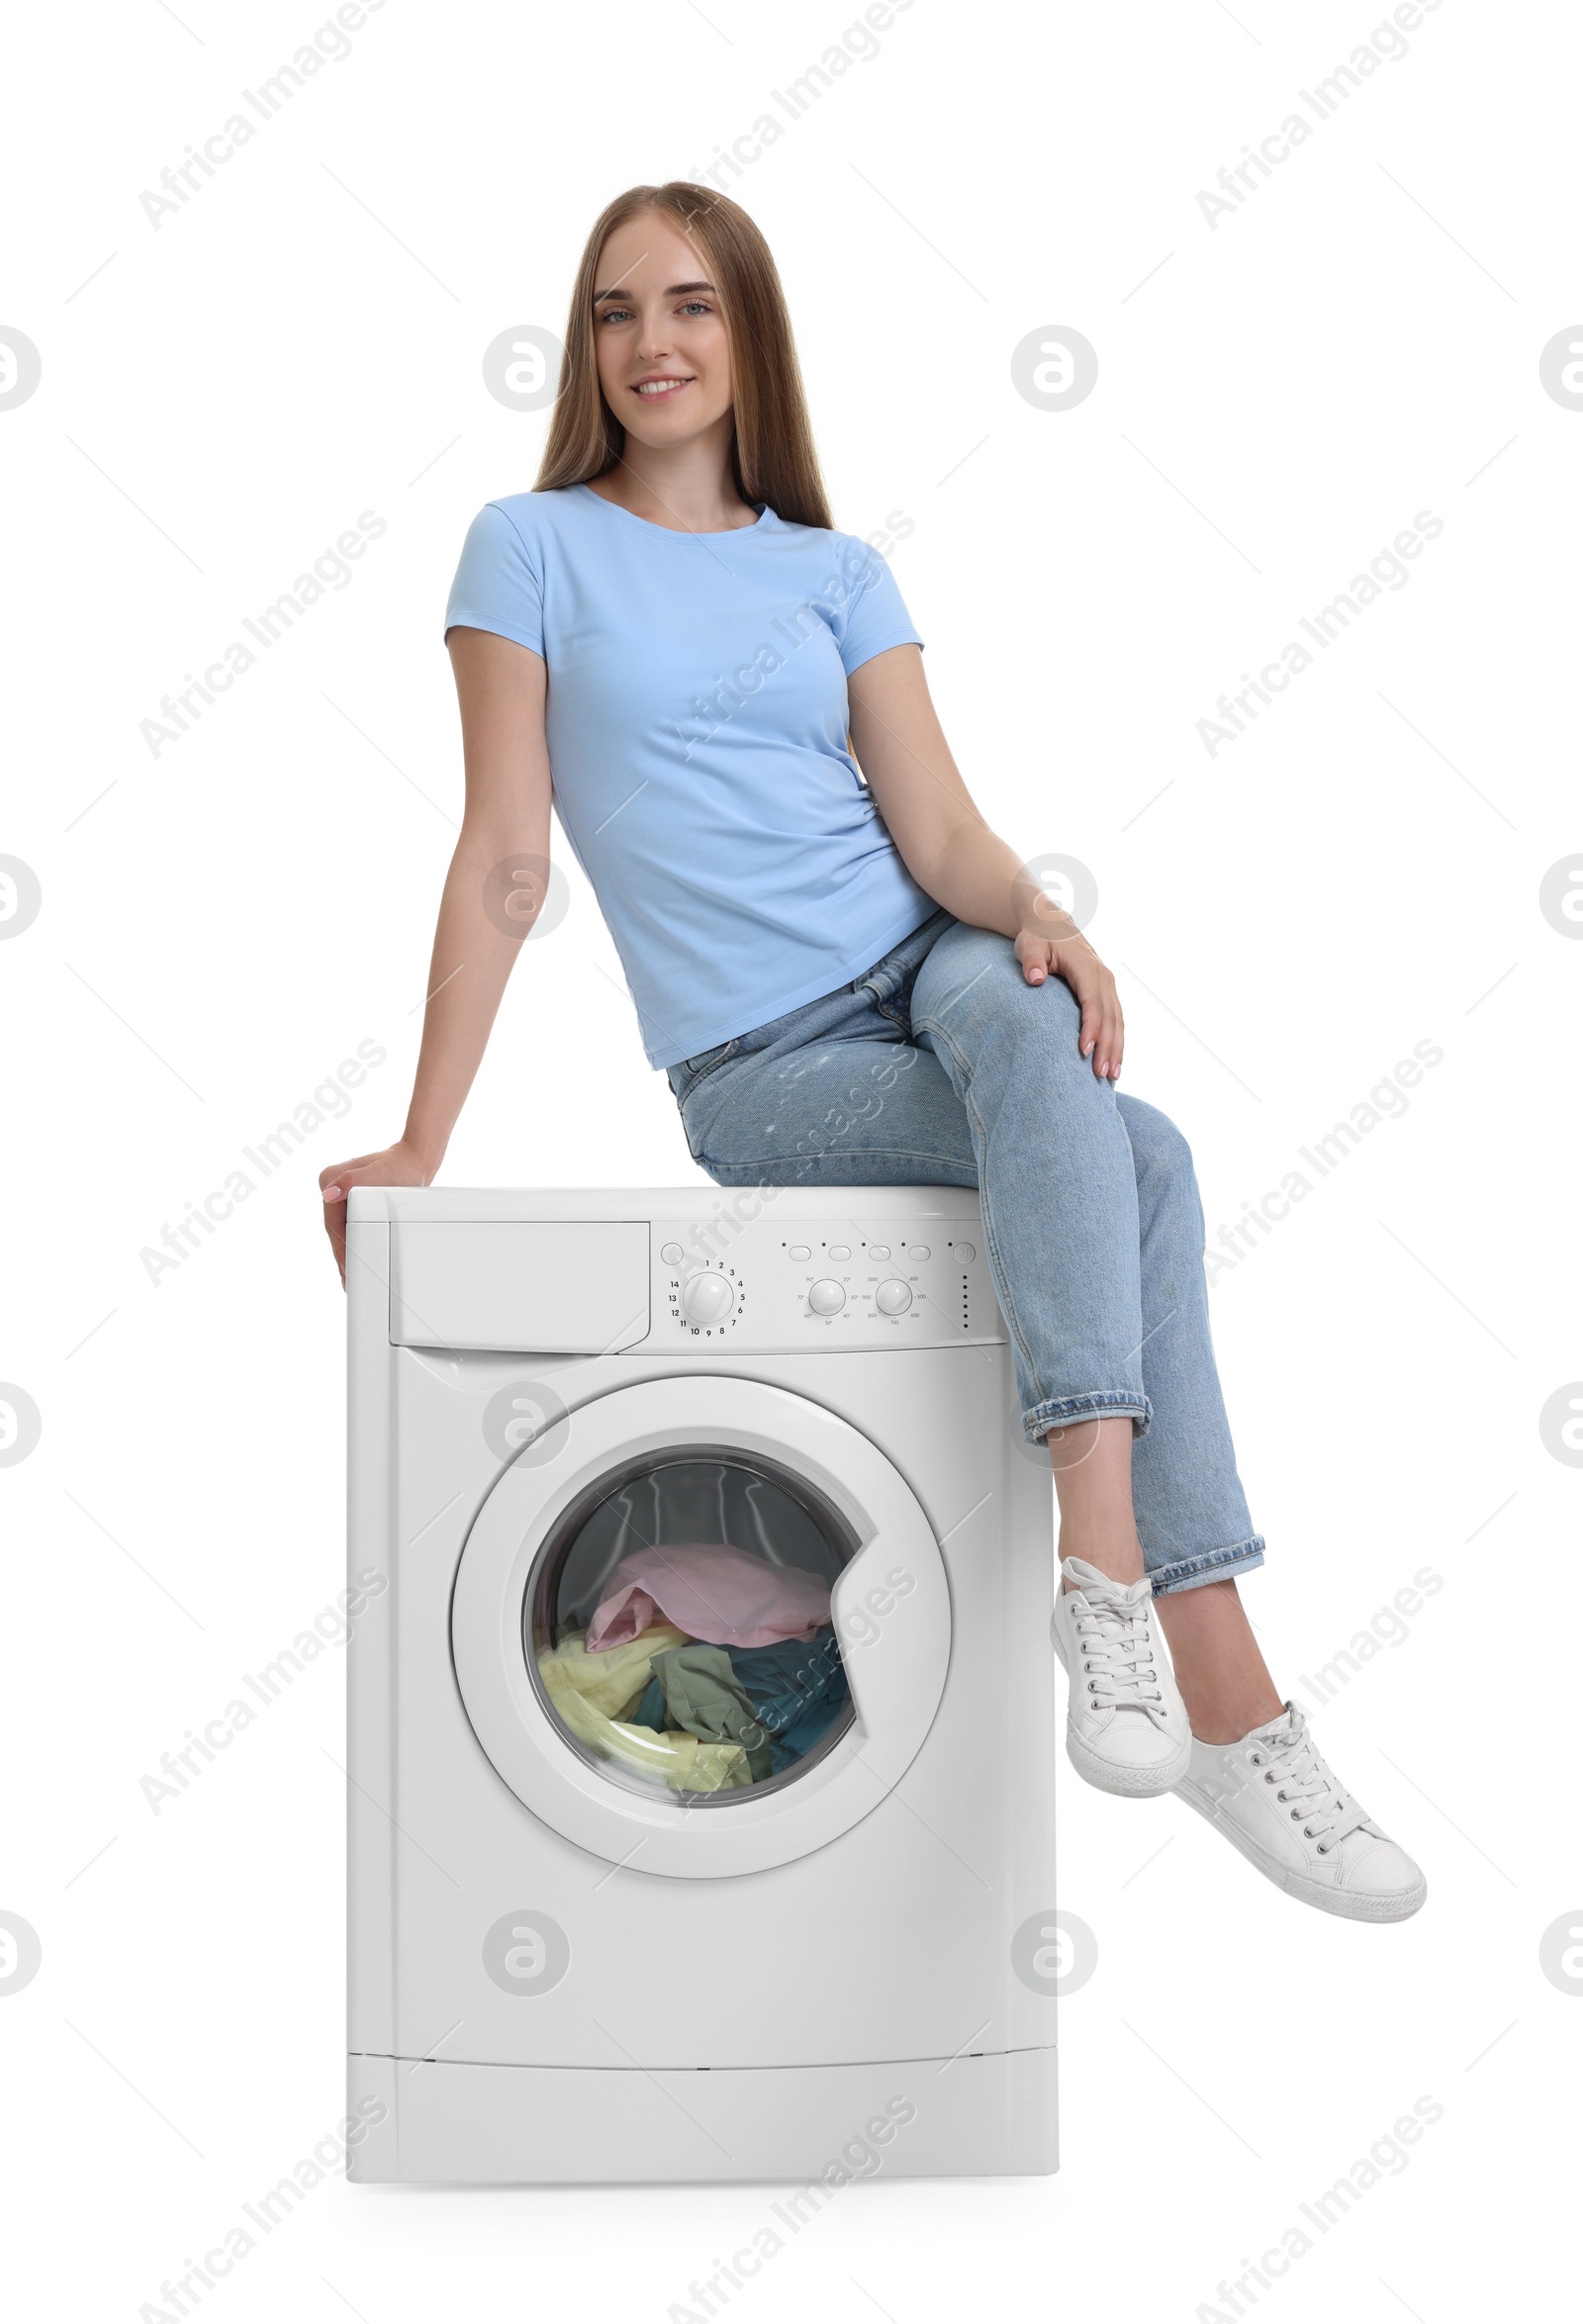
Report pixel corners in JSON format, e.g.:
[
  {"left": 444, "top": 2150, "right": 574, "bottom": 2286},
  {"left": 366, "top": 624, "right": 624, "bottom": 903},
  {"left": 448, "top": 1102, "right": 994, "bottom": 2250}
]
[{"left": 670, "top": 911, "right": 1264, "bottom": 1594}]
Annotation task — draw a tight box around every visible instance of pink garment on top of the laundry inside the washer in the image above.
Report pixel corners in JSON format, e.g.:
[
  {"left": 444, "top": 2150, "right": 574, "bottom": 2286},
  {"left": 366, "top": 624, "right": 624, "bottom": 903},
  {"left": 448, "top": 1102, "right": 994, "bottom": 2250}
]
[{"left": 588, "top": 1540, "right": 830, "bottom": 1654}]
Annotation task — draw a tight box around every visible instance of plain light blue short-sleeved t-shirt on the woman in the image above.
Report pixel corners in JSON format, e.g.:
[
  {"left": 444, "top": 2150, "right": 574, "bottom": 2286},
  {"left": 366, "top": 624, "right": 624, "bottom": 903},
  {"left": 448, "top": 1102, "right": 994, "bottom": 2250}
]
[{"left": 446, "top": 484, "right": 934, "bottom": 1067}]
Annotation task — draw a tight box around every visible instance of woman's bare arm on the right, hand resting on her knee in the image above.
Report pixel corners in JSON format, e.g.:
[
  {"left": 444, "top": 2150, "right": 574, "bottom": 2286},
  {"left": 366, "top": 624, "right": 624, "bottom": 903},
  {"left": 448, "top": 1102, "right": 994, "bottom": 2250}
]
[{"left": 846, "top": 646, "right": 1125, "bottom": 1080}]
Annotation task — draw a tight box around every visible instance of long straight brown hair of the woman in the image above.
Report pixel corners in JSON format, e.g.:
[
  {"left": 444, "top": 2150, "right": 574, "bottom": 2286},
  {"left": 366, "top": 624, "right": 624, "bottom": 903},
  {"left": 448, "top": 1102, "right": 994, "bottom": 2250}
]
[{"left": 534, "top": 179, "right": 832, "bottom": 532}]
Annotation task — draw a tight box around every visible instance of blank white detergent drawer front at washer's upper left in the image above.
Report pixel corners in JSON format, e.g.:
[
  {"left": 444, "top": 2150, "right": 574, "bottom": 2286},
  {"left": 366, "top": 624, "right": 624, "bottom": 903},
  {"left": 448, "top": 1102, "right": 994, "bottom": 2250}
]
[{"left": 391, "top": 1218, "right": 649, "bottom": 1354}]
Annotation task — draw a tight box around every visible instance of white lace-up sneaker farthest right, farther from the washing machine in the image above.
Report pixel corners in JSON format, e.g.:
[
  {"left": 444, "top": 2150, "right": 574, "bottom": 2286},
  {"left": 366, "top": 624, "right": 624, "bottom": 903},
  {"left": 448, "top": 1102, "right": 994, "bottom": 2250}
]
[{"left": 1176, "top": 1704, "right": 1430, "bottom": 1919}]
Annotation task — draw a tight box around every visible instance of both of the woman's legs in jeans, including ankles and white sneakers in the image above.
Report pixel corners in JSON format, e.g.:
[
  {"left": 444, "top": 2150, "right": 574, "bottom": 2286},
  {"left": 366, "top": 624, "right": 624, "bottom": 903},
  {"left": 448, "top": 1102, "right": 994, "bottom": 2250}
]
[{"left": 672, "top": 923, "right": 1425, "bottom": 1919}]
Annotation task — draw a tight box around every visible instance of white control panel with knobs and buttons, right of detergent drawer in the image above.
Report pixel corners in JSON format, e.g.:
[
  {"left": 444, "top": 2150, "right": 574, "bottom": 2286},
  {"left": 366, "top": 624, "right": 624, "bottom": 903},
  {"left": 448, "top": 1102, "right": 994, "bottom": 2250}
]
[{"left": 649, "top": 1216, "right": 1004, "bottom": 1350}]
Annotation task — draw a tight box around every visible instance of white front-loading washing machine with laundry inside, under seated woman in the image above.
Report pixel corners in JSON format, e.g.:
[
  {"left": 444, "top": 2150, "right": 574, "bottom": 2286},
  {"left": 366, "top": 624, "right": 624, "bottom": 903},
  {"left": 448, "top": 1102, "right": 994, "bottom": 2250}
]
[{"left": 346, "top": 1185, "right": 1060, "bottom": 2203}]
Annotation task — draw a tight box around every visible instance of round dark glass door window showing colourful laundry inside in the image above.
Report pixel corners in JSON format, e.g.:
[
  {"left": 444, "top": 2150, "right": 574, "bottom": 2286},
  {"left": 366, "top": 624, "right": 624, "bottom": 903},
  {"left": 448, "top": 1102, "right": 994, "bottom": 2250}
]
[{"left": 523, "top": 1445, "right": 858, "bottom": 1809}]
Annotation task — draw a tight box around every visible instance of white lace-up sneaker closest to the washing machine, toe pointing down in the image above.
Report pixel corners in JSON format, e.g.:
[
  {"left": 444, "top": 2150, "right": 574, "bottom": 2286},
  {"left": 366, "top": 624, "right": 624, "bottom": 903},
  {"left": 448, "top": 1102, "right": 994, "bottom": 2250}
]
[{"left": 1051, "top": 1557, "right": 1192, "bottom": 1799}]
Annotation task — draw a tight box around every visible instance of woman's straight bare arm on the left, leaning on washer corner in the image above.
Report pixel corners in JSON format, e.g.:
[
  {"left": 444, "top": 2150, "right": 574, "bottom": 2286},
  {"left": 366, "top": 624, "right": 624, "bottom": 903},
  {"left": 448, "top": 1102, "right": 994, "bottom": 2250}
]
[{"left": 319, "top": 627, "right": 551, "bottom": 1280}]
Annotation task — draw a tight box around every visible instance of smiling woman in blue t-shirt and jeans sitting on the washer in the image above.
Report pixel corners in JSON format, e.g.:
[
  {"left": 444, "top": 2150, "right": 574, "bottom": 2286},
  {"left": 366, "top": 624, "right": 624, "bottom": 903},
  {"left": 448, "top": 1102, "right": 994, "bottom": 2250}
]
[{"left": 321, "top": 184, "right": 1425, "bottom": 1919}]
